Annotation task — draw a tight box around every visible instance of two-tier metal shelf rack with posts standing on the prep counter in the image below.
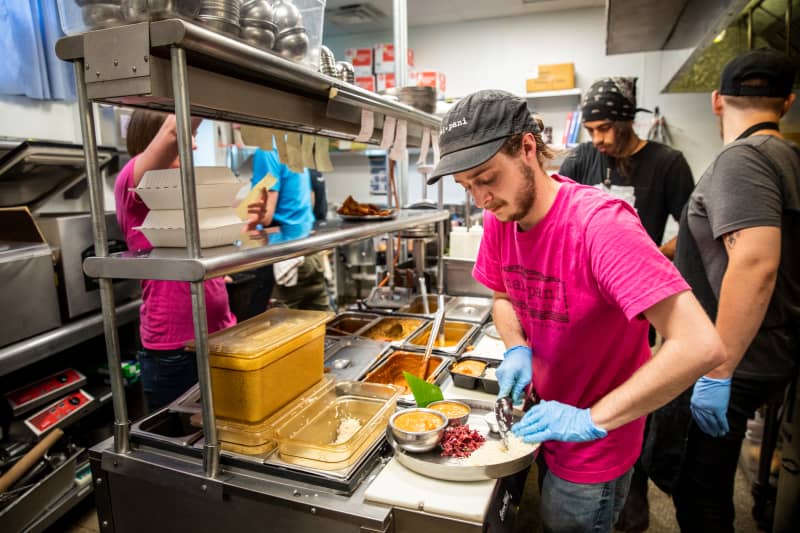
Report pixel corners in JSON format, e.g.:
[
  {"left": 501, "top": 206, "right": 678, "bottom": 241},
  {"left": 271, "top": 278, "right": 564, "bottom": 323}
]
[{"left": 56, "top": 20, "right": 448, "bottom": 480}]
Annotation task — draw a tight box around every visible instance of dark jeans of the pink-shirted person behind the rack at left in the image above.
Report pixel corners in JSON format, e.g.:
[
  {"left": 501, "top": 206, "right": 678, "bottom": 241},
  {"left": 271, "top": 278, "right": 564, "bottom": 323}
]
[{"left": 139, "top": 348, "right": 197, "bottom": 411}]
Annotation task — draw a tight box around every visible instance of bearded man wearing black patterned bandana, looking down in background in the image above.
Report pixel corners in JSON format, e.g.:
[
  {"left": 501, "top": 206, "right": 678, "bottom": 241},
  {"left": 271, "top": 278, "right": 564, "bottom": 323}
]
[{"left": 559, "top": 77, "right": 694, "bottom": 259}]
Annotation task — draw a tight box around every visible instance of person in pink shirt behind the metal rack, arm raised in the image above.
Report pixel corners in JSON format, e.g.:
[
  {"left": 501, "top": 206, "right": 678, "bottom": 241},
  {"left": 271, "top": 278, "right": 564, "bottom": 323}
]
[{"left": 114, "top": 109, "right": 236, "bottom": 410}]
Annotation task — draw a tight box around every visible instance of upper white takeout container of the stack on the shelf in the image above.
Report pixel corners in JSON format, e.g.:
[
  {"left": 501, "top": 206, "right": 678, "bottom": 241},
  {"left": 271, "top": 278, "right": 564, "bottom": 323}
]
[{"left": 131, "top": 167, "right": 249, "bottom": 210}]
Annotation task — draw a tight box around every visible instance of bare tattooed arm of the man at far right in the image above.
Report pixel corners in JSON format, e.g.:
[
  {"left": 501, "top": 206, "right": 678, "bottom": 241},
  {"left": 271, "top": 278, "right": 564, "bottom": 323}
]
[{"left": 707, "top": 226, "right": 781, "bottom": 378}]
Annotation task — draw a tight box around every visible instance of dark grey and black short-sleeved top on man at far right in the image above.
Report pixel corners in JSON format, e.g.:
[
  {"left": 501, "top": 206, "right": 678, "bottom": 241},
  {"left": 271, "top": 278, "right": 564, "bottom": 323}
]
[{"left": 675, "top": 135, "right": 800, "bottom": 379}]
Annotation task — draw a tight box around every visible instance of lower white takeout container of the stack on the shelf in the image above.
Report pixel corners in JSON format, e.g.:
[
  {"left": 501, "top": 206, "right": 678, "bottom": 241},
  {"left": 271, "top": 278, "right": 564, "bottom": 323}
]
[{"left": 133, "top": 207, "right": 244, "bottom": 248}]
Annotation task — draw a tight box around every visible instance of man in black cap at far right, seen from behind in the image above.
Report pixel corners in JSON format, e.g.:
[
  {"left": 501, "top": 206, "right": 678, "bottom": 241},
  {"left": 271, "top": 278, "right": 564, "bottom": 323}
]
[{"left": 644, "top": 49, "right": 800, "bottom": 532}]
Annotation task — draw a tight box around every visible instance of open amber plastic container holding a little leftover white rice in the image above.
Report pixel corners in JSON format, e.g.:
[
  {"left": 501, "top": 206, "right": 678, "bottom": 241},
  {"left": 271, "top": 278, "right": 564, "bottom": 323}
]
[{"left": 275, "top": 381, "right": 400, "bottom": 470}]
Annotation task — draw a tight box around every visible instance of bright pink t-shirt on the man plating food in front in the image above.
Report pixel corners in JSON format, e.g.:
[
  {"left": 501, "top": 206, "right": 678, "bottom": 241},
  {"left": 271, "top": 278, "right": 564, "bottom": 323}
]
[{"left": 473, "top": 175, "right": 689, "bottom": 483}]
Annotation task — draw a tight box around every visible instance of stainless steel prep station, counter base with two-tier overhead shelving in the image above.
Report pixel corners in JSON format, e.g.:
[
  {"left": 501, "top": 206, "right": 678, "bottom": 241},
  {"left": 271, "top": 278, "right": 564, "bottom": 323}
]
[{"left": 56, "top": 19, "right": 519, "bottom": 532}]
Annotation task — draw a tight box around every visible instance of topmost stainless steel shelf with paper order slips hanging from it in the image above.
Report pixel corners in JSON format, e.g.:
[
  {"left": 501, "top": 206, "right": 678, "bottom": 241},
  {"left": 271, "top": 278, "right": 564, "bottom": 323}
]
[{"left": 56, "top": 19, "right": 441, "bottom": 146}]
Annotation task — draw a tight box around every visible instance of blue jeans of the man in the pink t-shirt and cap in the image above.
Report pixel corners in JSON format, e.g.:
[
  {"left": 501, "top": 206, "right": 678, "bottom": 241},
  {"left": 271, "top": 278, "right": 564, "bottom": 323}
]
[{"left": 542, "top": 468, "right": 633, "bottom": 533}]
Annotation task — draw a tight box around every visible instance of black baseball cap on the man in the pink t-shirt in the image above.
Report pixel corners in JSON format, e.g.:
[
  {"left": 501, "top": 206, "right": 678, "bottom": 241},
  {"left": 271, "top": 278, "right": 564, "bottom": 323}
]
[{"left": 428, "top": 90, "right": 539, "bottom": 185}]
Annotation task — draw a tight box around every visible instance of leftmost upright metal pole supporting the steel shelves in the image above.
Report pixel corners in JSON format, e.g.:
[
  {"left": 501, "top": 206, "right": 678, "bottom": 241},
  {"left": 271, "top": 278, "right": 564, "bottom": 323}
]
[{"left": 73, "top": 59, "right": 130, "bottom": 453}]
